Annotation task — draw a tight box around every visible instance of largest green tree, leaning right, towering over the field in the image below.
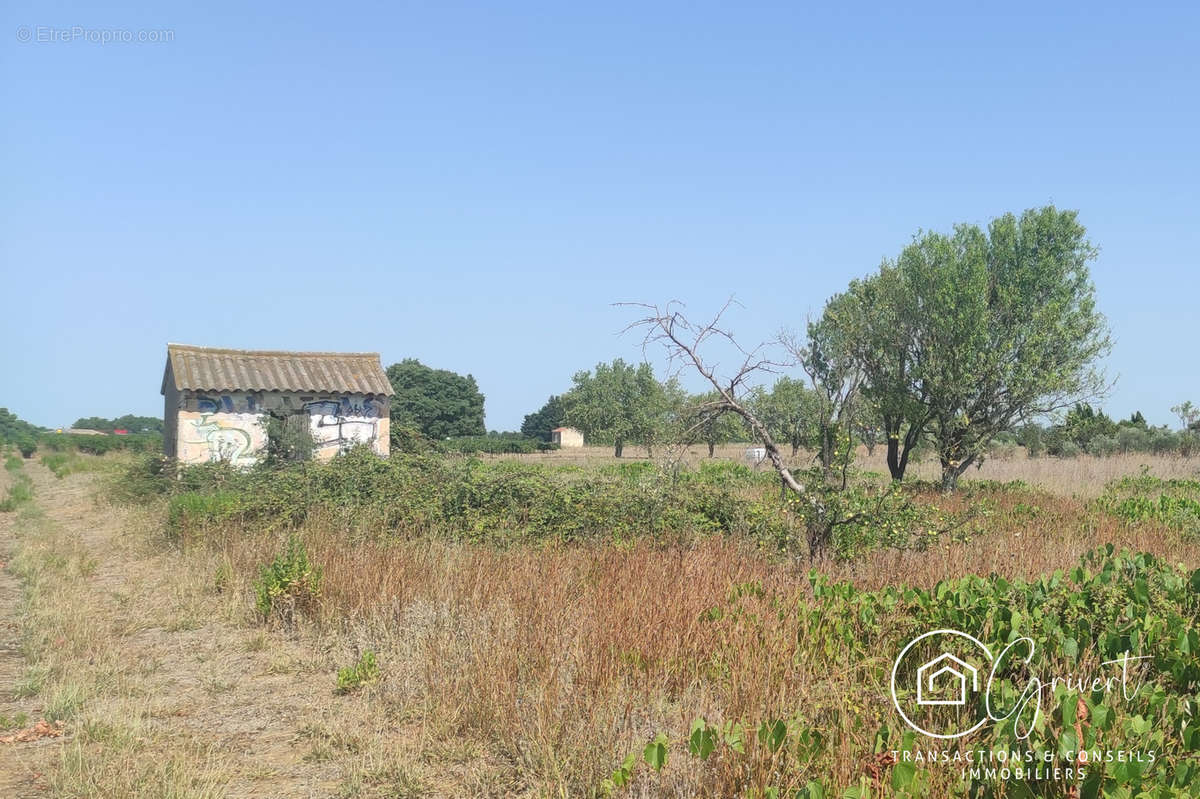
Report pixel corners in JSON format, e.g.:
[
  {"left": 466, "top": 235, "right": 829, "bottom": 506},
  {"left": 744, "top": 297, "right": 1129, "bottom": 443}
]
[{"left": 822, "top": 206, "right": 1110, "bottom": 491}]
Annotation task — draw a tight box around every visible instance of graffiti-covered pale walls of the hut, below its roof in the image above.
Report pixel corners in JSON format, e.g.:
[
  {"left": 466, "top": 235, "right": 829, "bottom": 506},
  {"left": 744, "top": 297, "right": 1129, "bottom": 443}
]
[{"left": 164, "top": 390, "right": 389, "bottom": 465}]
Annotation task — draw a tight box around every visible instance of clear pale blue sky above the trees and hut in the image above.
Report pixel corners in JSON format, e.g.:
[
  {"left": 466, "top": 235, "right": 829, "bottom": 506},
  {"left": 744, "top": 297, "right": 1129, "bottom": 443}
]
[{"left": 0, "top": 1, "right": 1200, "bottom": 429}]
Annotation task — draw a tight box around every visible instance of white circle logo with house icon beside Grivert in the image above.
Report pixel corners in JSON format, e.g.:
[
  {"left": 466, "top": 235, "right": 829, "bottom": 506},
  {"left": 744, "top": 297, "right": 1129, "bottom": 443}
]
[{"left": 892, "top": 629, "right": 995, "bottom": 740}]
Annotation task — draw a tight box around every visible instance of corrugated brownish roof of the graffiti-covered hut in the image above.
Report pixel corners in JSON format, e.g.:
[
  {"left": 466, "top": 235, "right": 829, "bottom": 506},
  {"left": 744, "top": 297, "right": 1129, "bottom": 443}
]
[{"left": 163, "top": 344, "right": 395, "bottom": 397}]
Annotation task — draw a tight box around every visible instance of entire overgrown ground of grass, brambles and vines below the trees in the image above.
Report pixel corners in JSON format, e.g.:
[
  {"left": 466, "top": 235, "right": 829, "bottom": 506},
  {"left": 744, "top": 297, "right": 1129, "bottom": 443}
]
[{"left": 0, "top": 447, "right": 1200, "bottom": 798}]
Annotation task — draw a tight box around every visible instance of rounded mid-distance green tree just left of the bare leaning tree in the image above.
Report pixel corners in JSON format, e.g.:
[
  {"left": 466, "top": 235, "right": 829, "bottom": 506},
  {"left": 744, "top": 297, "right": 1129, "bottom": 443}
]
[{"left": 563, "top": 358, "right": 680, "bottom": 458}]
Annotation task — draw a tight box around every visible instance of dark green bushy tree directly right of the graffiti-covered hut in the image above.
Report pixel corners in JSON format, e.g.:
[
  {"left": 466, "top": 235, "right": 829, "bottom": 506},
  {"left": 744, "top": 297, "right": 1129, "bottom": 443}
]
[{"left": 388, "top": 358, "right": 487, "bottom": 440}]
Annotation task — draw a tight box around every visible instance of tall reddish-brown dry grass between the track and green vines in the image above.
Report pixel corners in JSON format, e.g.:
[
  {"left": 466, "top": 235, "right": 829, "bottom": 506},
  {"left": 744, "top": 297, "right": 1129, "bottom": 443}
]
[{"left": 199, "top": 482, "right": 1200, "bottom": 795}]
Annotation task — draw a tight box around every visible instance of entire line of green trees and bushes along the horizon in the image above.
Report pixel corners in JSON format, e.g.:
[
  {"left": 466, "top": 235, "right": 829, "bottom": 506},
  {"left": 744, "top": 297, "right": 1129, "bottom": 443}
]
[{"left": 0, "top": 206, "right": 1200, "bottom": 472}]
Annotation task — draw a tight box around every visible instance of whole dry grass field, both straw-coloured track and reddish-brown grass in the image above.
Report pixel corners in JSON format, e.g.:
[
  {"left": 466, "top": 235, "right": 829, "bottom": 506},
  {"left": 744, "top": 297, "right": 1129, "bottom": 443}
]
[{"left": 0, "top": 447, "right": 1200, "bottom": 798}]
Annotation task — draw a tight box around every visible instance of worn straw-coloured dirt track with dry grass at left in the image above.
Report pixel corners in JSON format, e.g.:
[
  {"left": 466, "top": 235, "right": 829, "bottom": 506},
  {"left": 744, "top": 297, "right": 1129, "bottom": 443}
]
[{"left": 0, "top": 462, "right": 403, "bottom": 797}]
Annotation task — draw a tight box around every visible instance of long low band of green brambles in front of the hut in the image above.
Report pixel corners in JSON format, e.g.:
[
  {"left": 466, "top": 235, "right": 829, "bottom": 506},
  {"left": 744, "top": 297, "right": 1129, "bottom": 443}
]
[{"left": 140, "top": 447, "right": 979, "bottom": 557}]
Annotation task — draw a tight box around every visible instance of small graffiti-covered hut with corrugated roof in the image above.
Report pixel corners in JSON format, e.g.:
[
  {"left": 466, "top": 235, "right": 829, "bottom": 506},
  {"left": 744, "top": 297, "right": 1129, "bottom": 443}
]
[{"left": 162, "top": 344, "right": 394, "bottom": 465}]
